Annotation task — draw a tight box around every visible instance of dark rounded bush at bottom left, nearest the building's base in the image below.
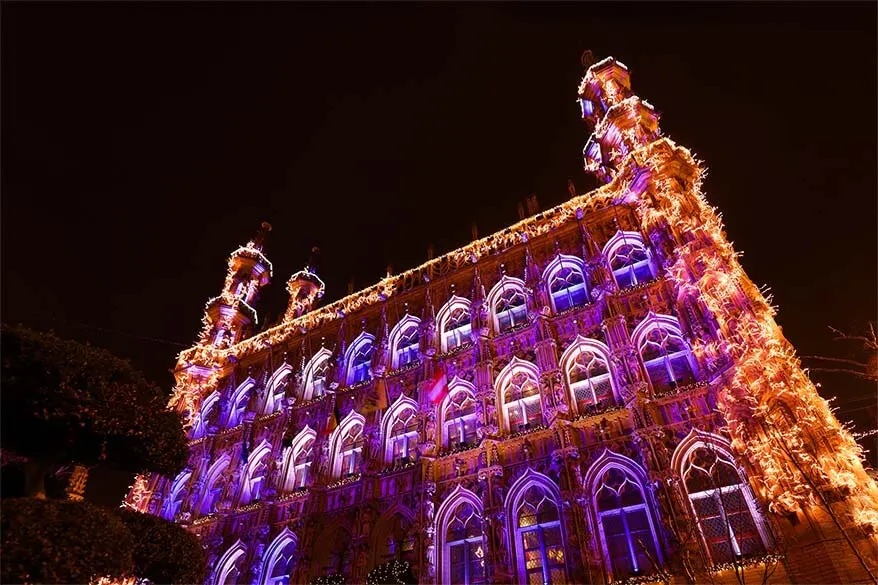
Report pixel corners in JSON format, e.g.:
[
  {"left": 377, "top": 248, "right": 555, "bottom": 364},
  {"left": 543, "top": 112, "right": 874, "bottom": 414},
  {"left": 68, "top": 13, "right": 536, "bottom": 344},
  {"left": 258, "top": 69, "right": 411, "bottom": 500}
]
[{"left": 119, "top": 509, "right": 207, "bottom": 583}]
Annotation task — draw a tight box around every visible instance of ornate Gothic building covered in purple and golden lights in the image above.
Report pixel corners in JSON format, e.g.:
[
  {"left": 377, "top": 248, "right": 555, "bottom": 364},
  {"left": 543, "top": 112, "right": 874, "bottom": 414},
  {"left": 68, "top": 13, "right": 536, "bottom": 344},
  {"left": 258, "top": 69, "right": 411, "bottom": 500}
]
[{"left": 126, "top": 58, "right": 878, "bottom": 585}]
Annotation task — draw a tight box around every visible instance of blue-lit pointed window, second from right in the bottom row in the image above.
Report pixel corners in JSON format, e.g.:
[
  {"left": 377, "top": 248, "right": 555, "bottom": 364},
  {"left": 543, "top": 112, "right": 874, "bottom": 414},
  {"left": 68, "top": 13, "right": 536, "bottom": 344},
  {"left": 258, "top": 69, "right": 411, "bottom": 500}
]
[{"left": 595, "top": 467, "right": 659, "bottom": 581}]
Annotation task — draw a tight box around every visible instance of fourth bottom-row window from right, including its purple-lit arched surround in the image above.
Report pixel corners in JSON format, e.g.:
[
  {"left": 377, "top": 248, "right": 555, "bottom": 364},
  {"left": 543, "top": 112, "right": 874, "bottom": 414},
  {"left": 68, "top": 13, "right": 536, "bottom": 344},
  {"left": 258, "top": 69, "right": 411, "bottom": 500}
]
[{"left": 436, "top": 486, "right": 487, "bottom": 585}]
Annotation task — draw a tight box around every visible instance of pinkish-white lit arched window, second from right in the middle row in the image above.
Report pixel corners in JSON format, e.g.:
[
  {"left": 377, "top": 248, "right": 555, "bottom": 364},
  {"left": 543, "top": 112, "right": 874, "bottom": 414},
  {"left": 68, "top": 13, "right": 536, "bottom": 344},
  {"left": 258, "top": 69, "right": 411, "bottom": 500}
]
[{"left": 561, "top": 337, "right": 615, "bottom": 414}]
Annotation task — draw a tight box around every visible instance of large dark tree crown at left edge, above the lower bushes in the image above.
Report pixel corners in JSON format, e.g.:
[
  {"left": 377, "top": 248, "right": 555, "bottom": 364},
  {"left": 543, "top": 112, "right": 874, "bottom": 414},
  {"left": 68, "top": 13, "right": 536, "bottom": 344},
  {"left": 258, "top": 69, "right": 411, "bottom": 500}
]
[{"left": 0, "top": 326, "right": 188, "bottom": 476}]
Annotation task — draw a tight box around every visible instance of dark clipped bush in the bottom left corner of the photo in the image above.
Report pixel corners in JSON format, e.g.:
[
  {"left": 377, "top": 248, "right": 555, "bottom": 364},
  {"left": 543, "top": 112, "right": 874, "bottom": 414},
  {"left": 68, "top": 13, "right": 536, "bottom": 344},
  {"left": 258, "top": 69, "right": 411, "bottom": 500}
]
[{"left": 0, "top": 498, "right": 134, "bottom": 583}]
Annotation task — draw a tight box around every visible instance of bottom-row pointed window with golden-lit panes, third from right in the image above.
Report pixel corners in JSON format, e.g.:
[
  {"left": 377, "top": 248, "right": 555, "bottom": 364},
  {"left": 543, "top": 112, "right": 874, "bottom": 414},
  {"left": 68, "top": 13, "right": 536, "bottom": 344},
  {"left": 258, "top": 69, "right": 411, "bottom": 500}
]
[{"left": 514, "top": 485, "right": 567, "bottom": 583}]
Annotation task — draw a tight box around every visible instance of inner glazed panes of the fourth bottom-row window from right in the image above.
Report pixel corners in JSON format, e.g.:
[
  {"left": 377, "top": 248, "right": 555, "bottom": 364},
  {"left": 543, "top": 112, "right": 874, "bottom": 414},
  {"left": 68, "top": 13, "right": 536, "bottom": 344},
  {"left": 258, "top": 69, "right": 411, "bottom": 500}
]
[{"left": 443, "top": 500, "right": 487, "bottom": 585}]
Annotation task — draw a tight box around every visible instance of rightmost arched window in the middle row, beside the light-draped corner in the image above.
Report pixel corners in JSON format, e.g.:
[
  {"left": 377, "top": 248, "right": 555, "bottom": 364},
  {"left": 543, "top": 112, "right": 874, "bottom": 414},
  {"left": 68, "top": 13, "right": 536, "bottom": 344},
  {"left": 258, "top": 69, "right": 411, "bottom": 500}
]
[{"left": 633, "top": 313, "right": 696, "bottom": 392}]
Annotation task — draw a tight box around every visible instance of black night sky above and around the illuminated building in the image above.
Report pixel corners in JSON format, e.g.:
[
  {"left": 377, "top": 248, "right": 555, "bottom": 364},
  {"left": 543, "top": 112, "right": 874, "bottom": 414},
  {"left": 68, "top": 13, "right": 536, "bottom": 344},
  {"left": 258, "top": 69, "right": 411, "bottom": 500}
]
[{"left": 2, "top": 2, "right": 878, "bottom": 501}]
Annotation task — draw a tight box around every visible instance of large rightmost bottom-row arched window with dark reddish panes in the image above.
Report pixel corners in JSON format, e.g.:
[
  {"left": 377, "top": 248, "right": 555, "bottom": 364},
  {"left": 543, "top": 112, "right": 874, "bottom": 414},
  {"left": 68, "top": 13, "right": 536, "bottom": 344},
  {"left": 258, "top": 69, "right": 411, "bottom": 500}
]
[{"left": 673, "top": 430, "right": 768, "bottom": 564}]
